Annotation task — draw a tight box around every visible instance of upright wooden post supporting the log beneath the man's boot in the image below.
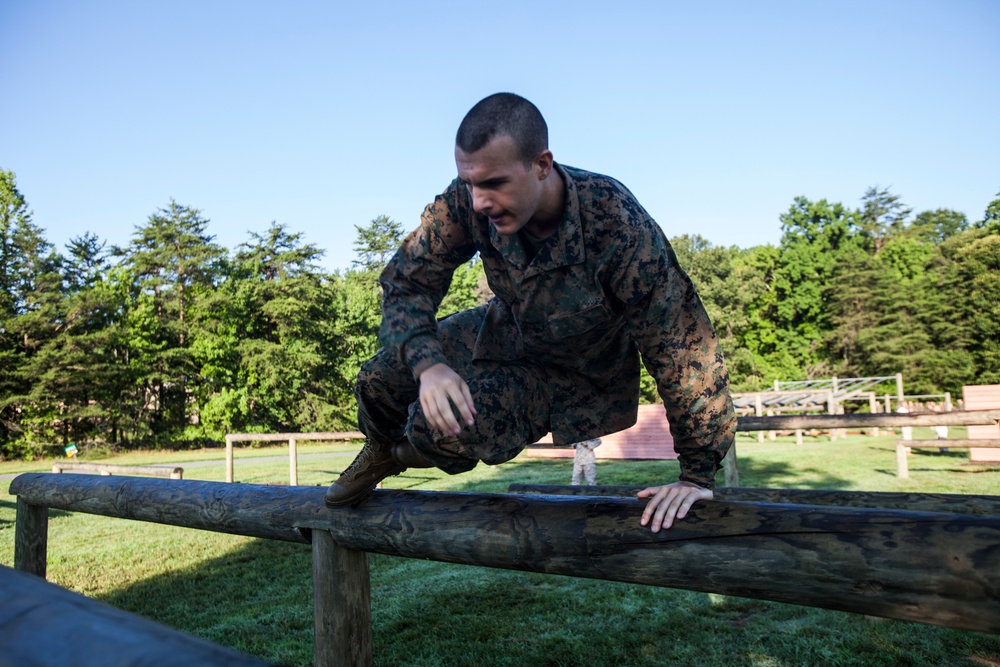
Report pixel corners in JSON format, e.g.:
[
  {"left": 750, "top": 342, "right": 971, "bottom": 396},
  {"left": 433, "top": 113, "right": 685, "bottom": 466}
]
[{"left": 312, "top": 530, "right": 373, "bottom": 667}]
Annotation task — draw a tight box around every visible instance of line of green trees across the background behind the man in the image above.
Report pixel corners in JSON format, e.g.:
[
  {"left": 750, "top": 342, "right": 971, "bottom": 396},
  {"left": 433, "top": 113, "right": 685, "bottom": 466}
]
[{"left": 0, "top": 170, "right": 1000, "bottom": 458}]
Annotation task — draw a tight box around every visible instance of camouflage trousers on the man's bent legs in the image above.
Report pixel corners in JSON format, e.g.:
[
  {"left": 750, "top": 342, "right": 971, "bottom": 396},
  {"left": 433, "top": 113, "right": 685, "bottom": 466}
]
[{"left": 355, "top": 306, "right": 550, "bottom": 474}]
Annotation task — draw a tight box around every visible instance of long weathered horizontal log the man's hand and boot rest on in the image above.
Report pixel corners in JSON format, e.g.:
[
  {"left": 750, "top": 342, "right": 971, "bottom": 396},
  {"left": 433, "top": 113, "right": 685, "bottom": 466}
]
[{"left": 10, "top": 473, "right": 1000, "bottom": 633}]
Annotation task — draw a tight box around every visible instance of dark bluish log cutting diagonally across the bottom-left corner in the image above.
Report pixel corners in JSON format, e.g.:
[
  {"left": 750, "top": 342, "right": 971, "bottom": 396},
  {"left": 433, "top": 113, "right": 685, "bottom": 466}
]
[{"left": 0, "top": 565, "right": 267, "bottom": 667}]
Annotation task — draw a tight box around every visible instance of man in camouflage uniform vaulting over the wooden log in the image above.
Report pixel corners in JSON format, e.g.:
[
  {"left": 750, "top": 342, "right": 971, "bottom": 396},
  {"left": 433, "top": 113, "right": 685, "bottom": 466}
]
[{"left": 327, "top": 93, "right": 736, "bottom": 531}]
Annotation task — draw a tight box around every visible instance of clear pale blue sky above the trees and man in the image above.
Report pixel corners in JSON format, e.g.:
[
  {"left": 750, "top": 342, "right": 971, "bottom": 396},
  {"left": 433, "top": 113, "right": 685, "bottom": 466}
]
[{"left": 0, "top": 0, "right": 1000, "bottom": 269}]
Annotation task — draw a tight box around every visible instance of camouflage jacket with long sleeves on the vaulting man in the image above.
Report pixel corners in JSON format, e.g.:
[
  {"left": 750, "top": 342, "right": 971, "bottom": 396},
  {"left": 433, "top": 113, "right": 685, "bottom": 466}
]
[{"left": 380, "top": 165, "right": 736, "bottom": 488}]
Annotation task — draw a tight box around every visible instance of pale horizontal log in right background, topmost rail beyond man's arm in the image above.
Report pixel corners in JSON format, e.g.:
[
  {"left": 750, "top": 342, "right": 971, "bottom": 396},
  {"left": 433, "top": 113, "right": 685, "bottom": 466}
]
[{"left": 736, "top": 410, "right": 1000, "bottom": 431}]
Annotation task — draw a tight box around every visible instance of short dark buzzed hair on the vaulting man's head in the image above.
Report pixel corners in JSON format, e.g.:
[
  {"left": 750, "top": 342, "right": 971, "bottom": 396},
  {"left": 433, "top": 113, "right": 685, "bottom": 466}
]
[{"left": 455, "top": 93, "right": 549, "bottom": 165}]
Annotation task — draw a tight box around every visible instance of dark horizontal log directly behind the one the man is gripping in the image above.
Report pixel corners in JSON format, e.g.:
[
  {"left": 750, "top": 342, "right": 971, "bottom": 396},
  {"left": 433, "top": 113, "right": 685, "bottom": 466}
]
[{"left": 508, "top": 484, "right": 1000, "bottom": 515}]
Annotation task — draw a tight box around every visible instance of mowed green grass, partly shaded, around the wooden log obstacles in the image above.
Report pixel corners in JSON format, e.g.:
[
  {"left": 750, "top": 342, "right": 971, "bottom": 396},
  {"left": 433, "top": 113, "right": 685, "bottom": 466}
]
[{"left": 0, "top": 429, "right": 1000, "bottom": 667}]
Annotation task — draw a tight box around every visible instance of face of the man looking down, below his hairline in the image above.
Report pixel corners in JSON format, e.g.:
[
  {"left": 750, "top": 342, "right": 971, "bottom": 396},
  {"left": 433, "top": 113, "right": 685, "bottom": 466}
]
[{"left": 455, "top": 136, "right": 544, "bottom": 235}]
